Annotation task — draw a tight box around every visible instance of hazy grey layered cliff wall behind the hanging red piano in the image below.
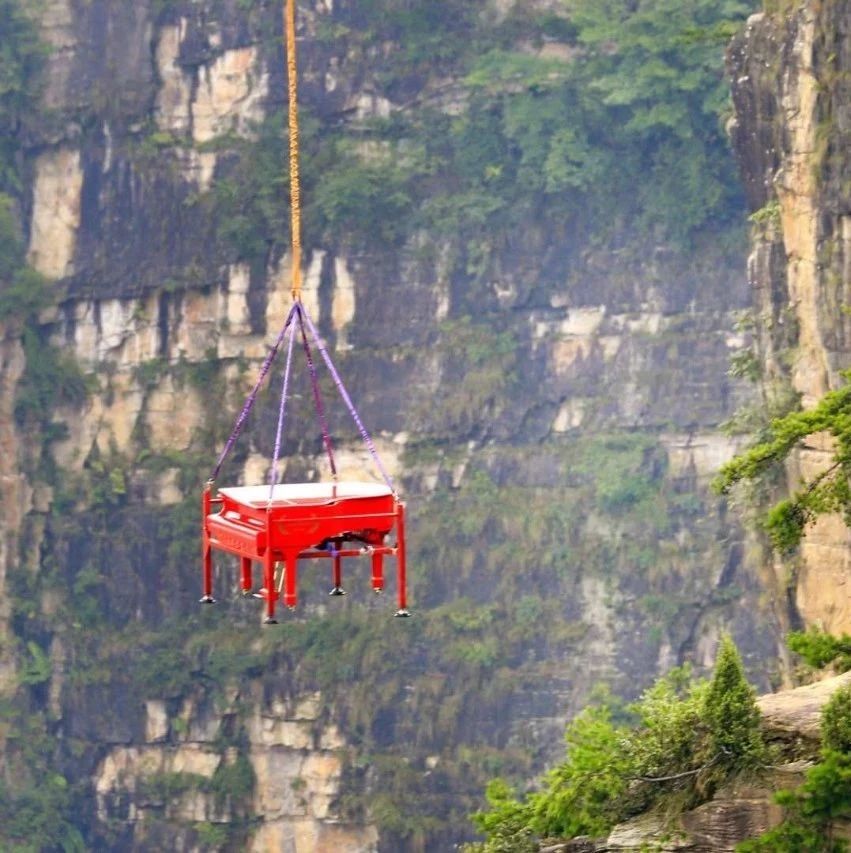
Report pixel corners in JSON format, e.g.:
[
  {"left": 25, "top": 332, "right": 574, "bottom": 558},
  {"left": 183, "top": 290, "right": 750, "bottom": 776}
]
[{"left": 0, "top": 0, "right": 804, "bottom": 851}]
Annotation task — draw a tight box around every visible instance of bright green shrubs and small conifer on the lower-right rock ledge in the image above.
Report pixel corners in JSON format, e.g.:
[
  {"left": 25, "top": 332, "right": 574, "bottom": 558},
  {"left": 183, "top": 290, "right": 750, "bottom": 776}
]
[{"left": 467, "top": 637, "right": 767, "bottom": 853}]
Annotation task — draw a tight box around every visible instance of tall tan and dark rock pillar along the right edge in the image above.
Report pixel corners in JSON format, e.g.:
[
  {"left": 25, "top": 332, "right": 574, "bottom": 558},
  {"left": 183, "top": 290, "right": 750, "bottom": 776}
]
[{"left": 730, "top": 3, "right": 851, "bottom": 633}]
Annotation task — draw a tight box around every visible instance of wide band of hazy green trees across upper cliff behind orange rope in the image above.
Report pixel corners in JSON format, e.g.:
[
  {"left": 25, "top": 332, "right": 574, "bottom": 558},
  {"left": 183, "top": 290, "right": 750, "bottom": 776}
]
[{"left": 205, "top": 0, "right": 752, "bottom": 274}]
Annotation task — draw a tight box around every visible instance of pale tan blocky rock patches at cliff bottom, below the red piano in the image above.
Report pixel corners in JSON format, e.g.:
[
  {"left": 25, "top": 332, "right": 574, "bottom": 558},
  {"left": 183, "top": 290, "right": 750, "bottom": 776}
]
[{"left": 94, "top": 693, "right": 378, "bottom": 853}]
